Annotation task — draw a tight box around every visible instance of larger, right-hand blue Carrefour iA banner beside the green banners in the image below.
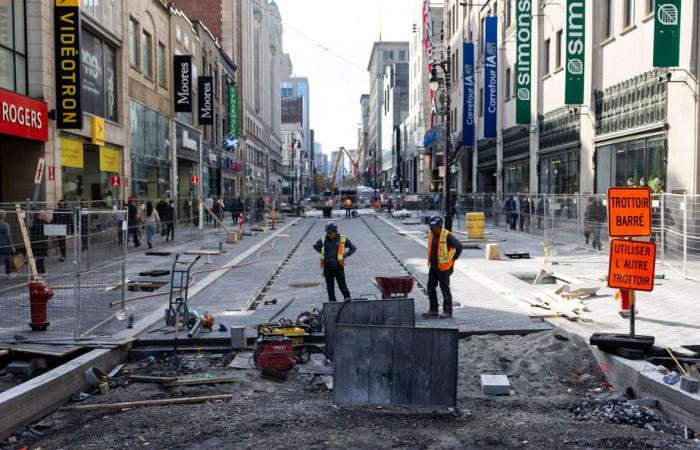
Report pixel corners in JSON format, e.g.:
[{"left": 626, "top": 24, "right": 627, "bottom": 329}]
[{"left": 483, "top": 16, "right": 498, "bottom": 139}]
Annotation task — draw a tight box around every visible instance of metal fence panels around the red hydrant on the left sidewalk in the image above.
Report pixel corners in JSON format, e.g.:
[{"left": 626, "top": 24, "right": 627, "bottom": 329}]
[{"left": 0, "top": 208, "right": 126, "bottom": 338}]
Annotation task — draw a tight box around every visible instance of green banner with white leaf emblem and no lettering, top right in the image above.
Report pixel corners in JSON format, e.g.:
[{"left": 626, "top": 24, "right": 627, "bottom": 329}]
[{"left": 654, "top": 0, "right": 681, "bottom": 67}]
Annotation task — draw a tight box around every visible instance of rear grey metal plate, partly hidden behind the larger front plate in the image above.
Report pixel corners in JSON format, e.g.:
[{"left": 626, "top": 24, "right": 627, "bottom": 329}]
[{"left": 323, "top": 298, "right": 416, "bottom": 356}]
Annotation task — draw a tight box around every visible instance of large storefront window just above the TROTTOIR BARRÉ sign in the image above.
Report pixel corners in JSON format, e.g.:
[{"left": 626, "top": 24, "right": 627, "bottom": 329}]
[{"left": 596, "top": 136, "right": 666, "bottom": 193}]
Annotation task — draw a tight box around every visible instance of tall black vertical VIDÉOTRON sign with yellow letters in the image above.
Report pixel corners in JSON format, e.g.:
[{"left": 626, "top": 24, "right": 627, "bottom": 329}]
[{"left": 54, "top": 0, "right": 83, "bottom": 129}]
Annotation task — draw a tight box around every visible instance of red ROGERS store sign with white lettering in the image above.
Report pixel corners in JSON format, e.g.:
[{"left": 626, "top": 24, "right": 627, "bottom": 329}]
[{"left": 0, "top": 89, "right": 49, "bottom": 142}]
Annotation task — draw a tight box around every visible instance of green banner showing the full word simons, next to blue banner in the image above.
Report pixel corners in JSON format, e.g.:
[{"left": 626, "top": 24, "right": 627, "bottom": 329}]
[{"left": 515, "top": 0, "right": 532, "bottom": 125}]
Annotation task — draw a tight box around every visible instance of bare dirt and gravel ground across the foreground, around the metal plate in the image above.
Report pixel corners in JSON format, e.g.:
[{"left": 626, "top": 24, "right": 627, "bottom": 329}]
[{"left": 6, "top": 332, "right": 700, "bottom": 449}]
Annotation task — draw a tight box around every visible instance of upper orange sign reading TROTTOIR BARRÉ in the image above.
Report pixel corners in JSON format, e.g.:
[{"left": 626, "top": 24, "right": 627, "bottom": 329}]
[{"left": 608, "top": 187, "right": 651, "bottom": 237}]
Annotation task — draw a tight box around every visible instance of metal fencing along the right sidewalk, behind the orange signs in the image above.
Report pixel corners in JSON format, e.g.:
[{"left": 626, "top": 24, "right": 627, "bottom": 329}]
[{"left": 405, "top": 193, "right": 700, "bottom": 281}]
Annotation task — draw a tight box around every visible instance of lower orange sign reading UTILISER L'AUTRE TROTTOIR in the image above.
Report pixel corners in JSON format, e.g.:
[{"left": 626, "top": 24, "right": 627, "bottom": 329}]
[{"left": 608, "top": 239, "right": 656, "bottom": 292}]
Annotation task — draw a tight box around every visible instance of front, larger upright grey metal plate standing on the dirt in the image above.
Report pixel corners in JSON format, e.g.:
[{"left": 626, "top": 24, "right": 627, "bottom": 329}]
[{"left": 333, "top": 324, "right": 459, "bottom": 407}]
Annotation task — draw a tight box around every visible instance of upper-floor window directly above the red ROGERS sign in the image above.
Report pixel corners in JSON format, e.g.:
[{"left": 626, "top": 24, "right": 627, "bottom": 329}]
[{"left": 0, "top": 0, "right": 27, "bottom": 95}]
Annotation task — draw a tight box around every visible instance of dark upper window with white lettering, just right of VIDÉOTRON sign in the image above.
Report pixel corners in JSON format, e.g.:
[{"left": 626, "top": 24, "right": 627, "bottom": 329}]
[{"left": 80, "top": 29, "right": 118, "bottom": 122}]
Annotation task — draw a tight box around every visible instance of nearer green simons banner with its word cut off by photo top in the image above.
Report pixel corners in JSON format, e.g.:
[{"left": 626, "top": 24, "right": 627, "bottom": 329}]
[{"left": 564, "top": 0, "right": 586, "bottom": 105}]
